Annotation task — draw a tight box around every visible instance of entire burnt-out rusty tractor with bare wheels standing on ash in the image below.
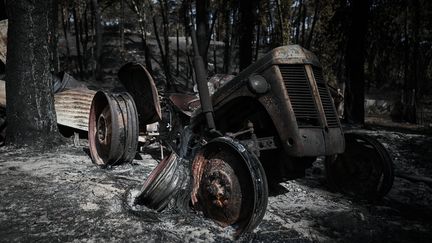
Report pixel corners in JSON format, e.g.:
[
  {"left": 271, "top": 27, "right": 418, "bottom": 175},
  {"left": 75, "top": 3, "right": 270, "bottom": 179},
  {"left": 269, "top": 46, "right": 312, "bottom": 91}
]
[{"left": 89, "top": 41, "right": 393, "bottom": 235}]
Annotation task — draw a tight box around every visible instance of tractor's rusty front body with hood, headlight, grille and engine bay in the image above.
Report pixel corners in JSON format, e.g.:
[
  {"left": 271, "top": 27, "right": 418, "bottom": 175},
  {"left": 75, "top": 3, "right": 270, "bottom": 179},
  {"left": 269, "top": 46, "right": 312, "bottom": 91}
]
[{"left": 191, "top": 45, "right": 344, "bottom": 183}]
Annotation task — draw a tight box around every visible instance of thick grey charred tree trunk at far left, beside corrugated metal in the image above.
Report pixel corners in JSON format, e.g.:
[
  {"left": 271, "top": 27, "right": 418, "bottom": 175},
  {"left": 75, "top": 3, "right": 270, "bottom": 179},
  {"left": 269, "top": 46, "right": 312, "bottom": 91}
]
[{"left": 6, "top": 0, "right": 59, "bottom": 148}]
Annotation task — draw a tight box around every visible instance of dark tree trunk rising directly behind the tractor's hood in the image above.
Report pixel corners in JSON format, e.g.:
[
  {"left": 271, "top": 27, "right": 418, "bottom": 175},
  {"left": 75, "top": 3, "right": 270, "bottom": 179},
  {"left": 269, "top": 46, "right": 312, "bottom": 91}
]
[{"left": 239, "top": 0, "right": 258, "bottom": 71}]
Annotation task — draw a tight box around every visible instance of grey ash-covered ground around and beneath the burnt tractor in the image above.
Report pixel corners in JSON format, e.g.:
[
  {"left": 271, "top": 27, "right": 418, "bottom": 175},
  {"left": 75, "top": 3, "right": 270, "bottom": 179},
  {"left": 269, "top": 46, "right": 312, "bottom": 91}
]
[{"left": 0, "top": 124, "right": 432, "bottom": 242}]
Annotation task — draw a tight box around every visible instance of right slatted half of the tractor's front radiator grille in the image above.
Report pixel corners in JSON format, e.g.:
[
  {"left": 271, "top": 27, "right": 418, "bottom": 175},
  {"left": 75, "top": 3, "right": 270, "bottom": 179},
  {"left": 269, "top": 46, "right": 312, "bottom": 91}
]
[{"left": 312, "top": 66, "right": 339, "bottom": 128}]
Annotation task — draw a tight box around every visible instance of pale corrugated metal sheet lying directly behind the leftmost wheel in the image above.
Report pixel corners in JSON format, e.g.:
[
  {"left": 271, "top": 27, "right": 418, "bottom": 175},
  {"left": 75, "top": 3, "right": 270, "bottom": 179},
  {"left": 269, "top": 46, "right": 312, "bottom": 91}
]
[{"left": 54, "top": 88, "right": 96, "bottom": 131}]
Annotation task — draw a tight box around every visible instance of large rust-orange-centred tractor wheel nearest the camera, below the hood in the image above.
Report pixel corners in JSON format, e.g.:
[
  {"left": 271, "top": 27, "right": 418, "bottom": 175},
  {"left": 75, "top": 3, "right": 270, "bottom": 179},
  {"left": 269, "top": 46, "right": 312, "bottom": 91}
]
[{"left": 191, "top": 137, "right": 268, "bottom": 235}]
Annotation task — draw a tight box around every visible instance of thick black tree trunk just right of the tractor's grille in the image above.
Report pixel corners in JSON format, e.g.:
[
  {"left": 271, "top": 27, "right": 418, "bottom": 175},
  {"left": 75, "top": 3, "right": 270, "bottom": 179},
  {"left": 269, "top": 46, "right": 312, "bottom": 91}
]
[{"left": 345, "top": 0, "right": 370, "bottom": 124}]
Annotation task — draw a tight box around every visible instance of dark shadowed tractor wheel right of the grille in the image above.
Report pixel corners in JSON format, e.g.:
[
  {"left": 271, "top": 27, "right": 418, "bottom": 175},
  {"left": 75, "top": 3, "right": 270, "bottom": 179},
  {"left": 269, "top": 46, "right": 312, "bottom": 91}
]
[{"left": 325, "top": 133, "right": 394, "bottom": 200}]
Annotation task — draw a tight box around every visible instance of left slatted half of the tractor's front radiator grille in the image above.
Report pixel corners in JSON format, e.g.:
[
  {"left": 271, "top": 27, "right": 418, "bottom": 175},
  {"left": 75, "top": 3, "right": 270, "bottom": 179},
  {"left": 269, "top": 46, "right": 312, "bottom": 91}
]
[{"left": 279, "top": 65, "right": 319, "bottom": 128}]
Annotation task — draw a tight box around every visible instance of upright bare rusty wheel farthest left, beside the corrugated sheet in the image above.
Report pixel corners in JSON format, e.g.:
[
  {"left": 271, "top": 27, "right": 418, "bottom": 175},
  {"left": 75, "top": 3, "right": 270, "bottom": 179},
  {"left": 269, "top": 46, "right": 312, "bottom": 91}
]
[{"left": 88, "top": 91, "right": 139, "bottom": 165}]
